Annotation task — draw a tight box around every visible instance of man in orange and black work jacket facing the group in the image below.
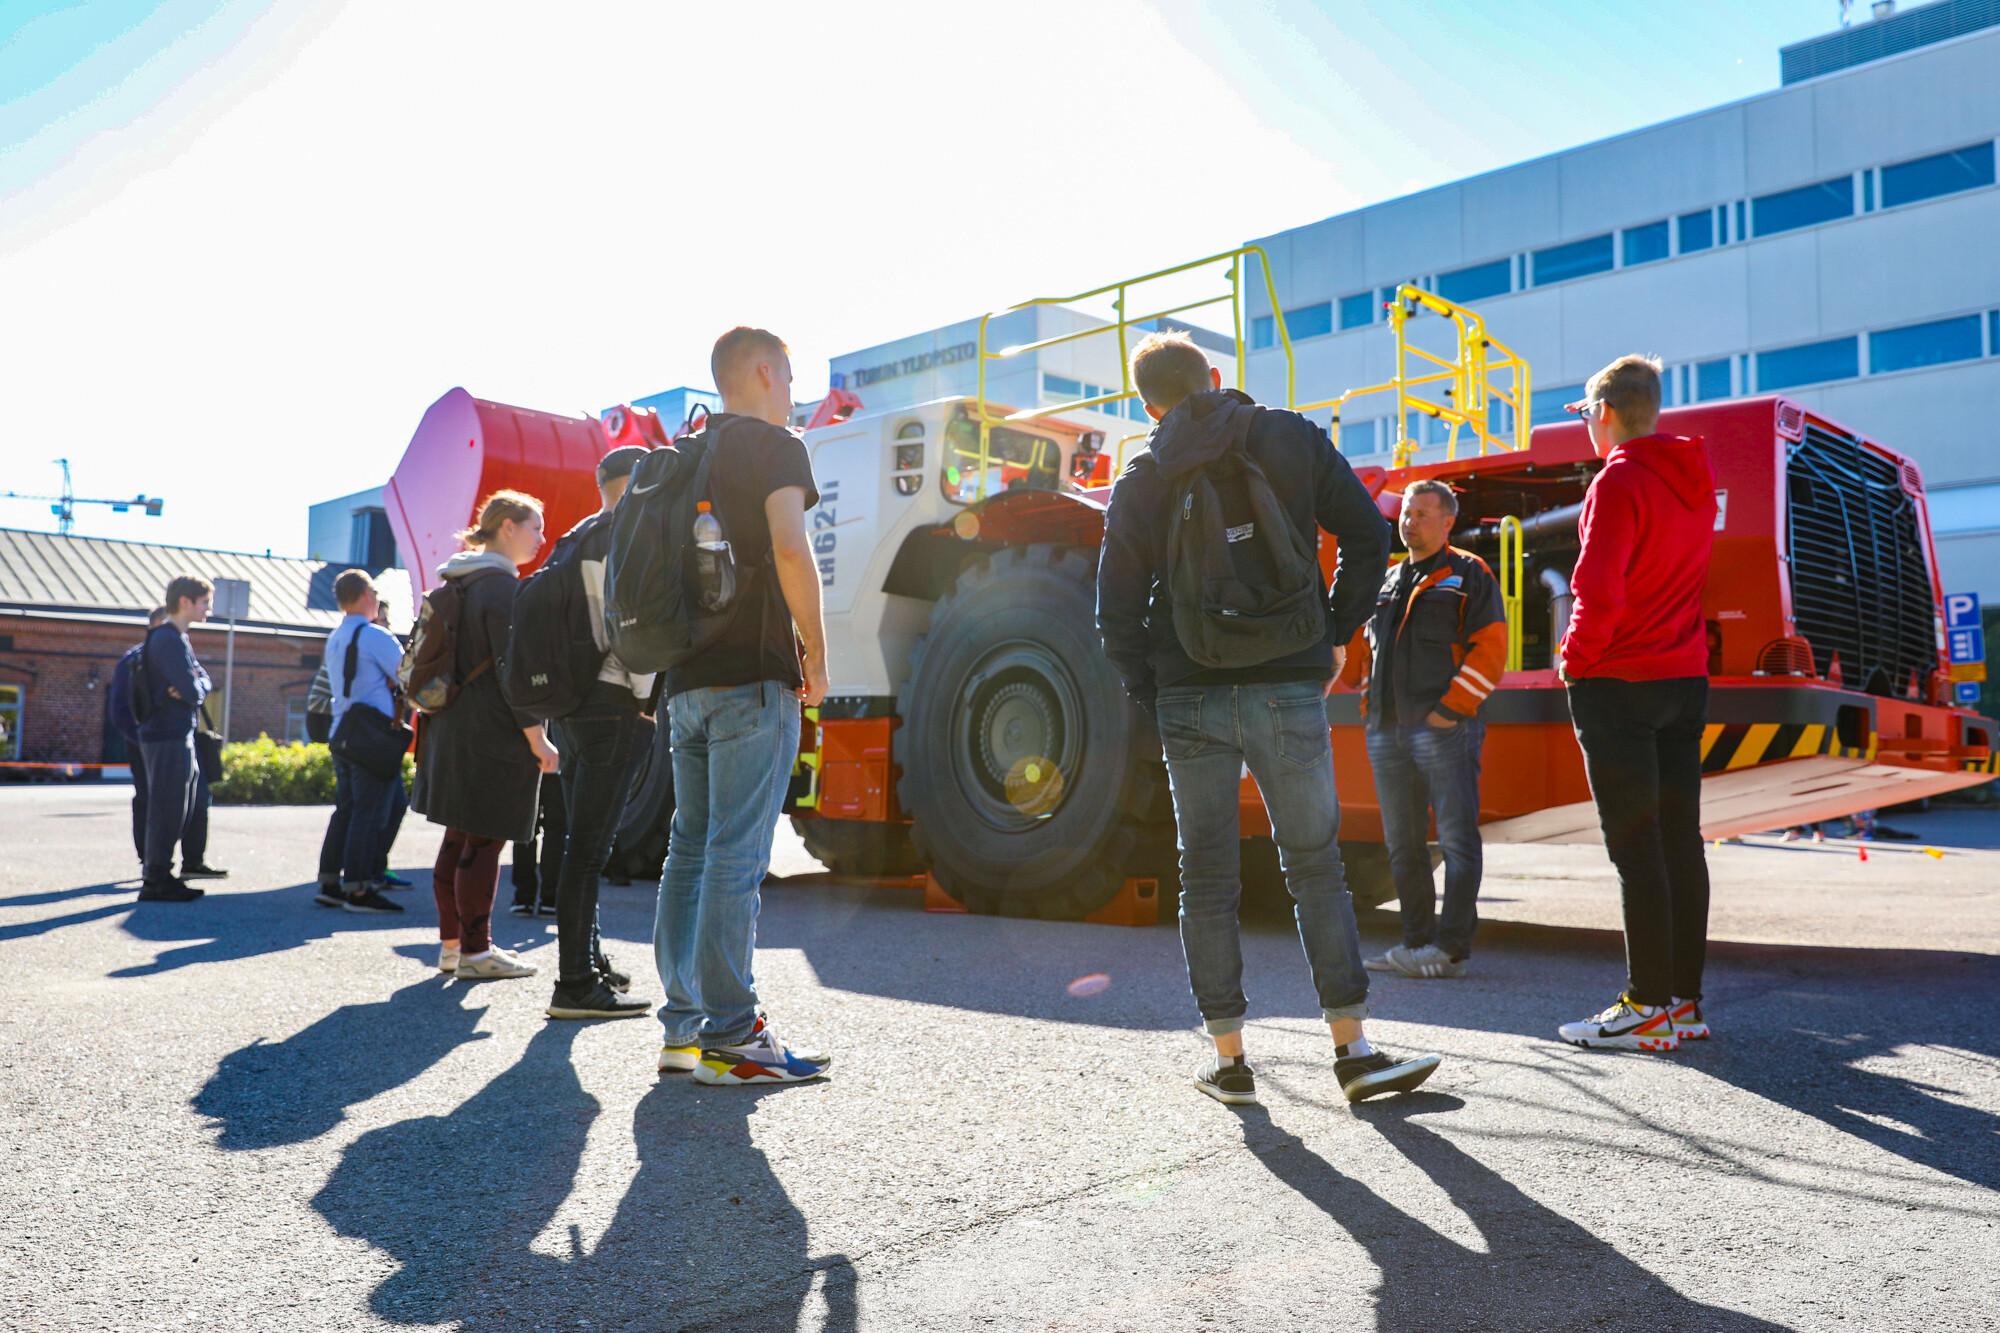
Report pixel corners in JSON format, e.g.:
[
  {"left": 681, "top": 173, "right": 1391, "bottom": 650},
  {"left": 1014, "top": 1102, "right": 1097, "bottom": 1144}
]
[{"left": 1340, "top": 480, "right": 1506, "bottom": 979}]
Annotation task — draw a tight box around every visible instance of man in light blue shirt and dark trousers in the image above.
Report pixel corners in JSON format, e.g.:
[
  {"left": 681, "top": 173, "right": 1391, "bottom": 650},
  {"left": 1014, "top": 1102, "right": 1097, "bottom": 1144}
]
[{"left": 314, "top": 568, "right": 402, "bottom": 913}]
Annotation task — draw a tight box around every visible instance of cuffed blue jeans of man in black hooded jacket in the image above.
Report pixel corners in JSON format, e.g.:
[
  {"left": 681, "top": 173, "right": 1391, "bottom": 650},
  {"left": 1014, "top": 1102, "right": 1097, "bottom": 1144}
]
[{"left": 1156, "top": 681, "right": 1368, "bottom": 1037}]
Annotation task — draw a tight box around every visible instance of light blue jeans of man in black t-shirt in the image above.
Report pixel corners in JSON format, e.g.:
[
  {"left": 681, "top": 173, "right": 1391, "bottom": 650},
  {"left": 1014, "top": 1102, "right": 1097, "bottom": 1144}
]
[{"left": 652, "top": 681, "right": 800, "bottom": 1047}]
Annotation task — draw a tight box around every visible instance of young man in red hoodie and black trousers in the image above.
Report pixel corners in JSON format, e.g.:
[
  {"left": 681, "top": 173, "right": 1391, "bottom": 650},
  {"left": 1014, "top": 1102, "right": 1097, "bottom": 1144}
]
[{"left": 1558, "top": 356, "right": 1716, "bottom": 1051}]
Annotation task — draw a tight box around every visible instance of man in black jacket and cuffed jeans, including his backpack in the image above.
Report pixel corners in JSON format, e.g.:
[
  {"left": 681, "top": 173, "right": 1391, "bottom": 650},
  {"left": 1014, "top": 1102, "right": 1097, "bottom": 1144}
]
[{"left": 1098, "top": 334, "right": 1438, "bottom": 1105}]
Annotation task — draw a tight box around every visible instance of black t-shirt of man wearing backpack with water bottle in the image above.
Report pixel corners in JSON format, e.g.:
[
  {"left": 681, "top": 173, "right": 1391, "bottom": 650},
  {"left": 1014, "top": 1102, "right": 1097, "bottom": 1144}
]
[{"left": 666, "top": 412, "right": 820, "bottom": 699}]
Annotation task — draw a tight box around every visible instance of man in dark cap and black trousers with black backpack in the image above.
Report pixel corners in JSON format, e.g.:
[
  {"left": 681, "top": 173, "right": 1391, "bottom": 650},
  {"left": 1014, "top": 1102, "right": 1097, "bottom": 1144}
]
[{"left": 500, "top": 444, "right": 654, "bottom": 1019}]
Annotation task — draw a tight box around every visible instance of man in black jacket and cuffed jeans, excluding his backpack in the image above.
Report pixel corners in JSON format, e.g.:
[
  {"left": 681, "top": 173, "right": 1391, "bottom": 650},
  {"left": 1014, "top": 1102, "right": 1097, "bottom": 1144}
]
[{"left": 1098, "top": 334, "right": 1438, "bottom": 1103}]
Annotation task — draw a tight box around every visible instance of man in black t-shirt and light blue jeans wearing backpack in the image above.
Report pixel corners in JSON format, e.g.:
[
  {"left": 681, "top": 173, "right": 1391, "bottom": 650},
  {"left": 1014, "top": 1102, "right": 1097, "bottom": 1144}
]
[{"left": 604, "top": 328, "right": 830, "bottom": 1085}]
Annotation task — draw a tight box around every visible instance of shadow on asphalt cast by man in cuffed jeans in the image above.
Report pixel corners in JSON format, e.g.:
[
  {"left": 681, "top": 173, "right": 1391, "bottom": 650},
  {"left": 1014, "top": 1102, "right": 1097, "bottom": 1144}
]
[{"left": 1238, "top": 1091, "right": 1780, "bottom": 1329}]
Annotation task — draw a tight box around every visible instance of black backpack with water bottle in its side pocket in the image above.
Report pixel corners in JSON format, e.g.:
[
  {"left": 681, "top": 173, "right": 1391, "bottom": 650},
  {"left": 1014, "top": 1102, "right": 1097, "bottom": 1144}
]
[{"left": 604, "top": 422, "right": 744, "bottom": 673}]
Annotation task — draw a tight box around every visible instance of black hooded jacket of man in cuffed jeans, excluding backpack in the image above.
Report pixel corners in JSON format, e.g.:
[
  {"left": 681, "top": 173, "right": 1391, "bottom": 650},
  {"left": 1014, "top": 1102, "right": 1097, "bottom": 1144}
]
[{"left": 1098, "top": 388, "right": 1388, "bottom": 709}]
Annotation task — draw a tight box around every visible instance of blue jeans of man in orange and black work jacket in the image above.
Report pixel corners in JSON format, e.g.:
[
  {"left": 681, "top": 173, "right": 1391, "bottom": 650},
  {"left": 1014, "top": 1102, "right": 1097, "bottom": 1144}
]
[{"left": 1368, "top": 721, "right": 1486, "bottom": 959}]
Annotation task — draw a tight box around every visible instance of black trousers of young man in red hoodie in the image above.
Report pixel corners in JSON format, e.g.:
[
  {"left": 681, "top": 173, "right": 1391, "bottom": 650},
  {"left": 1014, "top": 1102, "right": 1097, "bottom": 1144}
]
[{"left": 1570, "top": 677, "right": 1708, "bottom": 1005}]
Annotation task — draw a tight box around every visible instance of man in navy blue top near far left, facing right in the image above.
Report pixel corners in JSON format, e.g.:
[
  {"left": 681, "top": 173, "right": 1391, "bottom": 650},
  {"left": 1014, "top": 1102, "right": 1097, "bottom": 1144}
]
[{"left": 138, "top": 574, "right": 214, "bottom": 903}]
